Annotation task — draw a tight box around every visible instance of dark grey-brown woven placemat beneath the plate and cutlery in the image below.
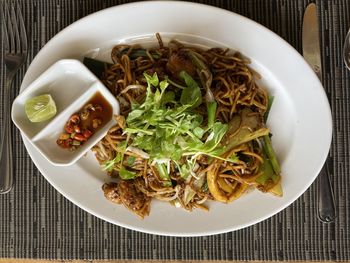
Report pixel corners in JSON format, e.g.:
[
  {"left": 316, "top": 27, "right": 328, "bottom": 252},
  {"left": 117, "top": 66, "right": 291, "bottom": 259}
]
[{"left": 0, "top": 0, "right": 350, "bottom": 260}]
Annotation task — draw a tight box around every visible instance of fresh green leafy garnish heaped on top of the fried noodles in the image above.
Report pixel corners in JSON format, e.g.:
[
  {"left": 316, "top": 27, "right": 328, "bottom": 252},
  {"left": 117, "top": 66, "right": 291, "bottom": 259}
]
[{"left": 105, "top": 71, "right": 237, "bottom": 183}]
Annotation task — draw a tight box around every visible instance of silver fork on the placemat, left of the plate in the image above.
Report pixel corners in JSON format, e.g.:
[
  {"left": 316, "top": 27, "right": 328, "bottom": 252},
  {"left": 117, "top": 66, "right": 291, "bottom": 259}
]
[{"left": 0, "top": 3, "right": 28, "bottom": 194}]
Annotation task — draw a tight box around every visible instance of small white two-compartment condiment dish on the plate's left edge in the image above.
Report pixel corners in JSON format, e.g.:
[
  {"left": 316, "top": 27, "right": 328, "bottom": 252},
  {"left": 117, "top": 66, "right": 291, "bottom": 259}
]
[{"left": 12, "top": 59, "right": 119, "bottom": 166}]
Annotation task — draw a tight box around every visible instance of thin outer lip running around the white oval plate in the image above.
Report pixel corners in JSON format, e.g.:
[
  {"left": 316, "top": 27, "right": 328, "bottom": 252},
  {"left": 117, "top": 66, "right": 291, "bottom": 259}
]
[{"left": 20, "top": 1, "right": 333, "bottom": 237}]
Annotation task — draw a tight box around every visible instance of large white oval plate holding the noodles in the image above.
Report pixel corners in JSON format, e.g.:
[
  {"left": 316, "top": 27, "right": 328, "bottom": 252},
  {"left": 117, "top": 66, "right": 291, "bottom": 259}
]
[{"left": 21, "top": 1, "right": 332, "bottom": 236}]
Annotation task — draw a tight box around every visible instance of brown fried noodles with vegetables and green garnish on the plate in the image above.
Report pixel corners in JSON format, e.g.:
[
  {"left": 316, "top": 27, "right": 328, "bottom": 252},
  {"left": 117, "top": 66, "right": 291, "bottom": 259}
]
[{"left": 84, "top": 34, "right": 282, "bottom": 218}]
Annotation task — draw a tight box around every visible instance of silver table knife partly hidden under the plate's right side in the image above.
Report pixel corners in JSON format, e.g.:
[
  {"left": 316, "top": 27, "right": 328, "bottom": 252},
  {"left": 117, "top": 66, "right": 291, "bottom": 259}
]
[{"left": 302, "top": 3, "right": 336, "bottom": 223}]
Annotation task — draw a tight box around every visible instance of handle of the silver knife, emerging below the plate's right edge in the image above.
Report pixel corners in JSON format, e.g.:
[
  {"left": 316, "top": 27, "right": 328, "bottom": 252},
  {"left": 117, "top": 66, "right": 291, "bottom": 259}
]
[{"left": 317, "top": 161, "right": 336, "bottom": 223}]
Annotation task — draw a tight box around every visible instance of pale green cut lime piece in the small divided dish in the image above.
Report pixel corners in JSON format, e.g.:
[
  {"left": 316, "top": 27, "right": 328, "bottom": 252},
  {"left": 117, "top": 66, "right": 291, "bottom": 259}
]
[{"left": 24, "top": 94, "right": 57, "bottom": 122}]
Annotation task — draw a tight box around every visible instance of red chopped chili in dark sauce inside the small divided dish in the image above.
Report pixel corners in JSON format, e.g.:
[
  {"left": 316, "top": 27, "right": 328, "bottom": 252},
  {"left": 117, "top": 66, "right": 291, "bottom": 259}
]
[{"left": 57, "top": 92, "right": 113, "bottom": 150}]
